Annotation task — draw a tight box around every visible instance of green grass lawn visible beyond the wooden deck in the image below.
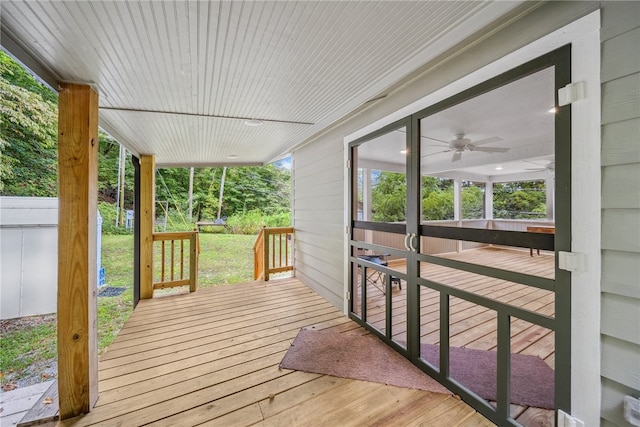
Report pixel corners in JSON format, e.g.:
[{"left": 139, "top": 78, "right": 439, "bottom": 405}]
[{"left": 0, "top": 233, "right": 256, "bottom": 384}]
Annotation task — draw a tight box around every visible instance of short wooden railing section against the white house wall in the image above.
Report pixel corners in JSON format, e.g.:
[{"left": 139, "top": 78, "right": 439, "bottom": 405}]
[{"left": 253, "top": 227, "right": 293, "bottom": 281}]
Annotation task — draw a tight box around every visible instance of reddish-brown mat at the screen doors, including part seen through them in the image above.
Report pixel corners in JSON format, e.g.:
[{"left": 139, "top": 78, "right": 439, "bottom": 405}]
[{"left": 280, "top": 329, "right": 554, "bottom": 409}]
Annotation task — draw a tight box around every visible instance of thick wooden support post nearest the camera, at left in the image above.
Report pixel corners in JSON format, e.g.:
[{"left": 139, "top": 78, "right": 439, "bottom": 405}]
[{"left": 58, "top": 83, "right": 98, "bottom": 420}]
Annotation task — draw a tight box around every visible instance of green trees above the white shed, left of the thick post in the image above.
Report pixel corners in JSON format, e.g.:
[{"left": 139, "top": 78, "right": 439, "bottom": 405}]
[{"left": 0, "top": 51, "right": 58, "bottom": 197}]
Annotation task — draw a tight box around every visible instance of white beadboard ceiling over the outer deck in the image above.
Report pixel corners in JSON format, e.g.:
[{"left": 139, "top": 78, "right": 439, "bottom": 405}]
[{"left": 0, "top": 0, "right": 520, "bottom": 166}]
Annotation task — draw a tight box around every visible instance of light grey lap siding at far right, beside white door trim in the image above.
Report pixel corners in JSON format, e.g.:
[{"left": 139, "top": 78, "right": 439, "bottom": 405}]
[{"left": 600, "top": 1, "right": 640, "bottom": 426}]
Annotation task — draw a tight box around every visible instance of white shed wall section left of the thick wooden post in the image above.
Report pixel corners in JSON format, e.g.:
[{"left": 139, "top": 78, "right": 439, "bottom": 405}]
[{"left": 0, "top": 197, "right": 58, "bottom": 319}]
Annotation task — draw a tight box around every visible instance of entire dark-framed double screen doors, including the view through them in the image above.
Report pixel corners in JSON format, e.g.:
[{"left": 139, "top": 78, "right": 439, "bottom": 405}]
[{"left": 349, "top": 47, "right": 571, "bottom": 425}]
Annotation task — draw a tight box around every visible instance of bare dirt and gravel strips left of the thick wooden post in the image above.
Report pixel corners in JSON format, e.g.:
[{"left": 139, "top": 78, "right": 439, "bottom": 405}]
[{"left": 0, "top": 314, "right": 58, "bottom": 391}]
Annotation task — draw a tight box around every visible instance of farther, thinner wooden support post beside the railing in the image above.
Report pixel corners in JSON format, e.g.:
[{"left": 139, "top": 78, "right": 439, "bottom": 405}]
[{"left": 140, "top": 155, "right": 156, "bottom": 299}]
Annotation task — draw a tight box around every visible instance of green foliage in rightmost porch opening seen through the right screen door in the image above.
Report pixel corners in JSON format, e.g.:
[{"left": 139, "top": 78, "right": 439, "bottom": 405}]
[{"left": 493, "top": 180, "right": 547, "bottom": 219}]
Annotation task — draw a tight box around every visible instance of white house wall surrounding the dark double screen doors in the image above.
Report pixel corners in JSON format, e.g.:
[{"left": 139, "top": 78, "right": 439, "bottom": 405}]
[{"left": 293, "top": 2, "right": 640, "bottom": 425}]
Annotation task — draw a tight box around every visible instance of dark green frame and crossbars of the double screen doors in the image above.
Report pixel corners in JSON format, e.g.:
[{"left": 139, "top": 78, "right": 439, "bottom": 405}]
[{"left": 348, "top": 45, "right": 571, "bottom": 425}]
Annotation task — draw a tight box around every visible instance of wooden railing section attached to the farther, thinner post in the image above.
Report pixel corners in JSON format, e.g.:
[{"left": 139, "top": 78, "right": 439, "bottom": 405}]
[{"left": 153, "top": 231, "right": 200, "bottom": 292}]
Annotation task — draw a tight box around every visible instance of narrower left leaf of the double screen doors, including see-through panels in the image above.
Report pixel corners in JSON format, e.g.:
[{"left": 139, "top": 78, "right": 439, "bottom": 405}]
[{"left": 349, "top": 120, "right": 411, "bottom": 352}]
